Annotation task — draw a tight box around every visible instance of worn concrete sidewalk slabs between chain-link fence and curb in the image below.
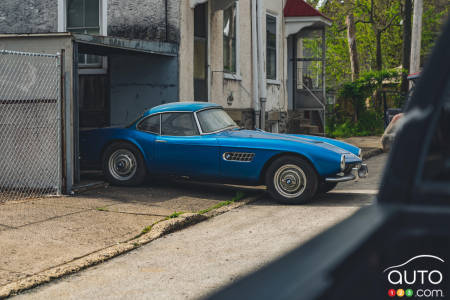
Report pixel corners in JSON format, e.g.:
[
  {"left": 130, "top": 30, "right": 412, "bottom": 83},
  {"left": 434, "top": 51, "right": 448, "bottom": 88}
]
[{"left": 0, "top": 180, "right": 260, "bottom": 298}]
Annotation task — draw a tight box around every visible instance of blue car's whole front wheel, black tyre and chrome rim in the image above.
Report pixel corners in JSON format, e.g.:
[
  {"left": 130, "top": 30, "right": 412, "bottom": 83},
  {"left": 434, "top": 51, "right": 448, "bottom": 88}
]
[{"left": 266, "top": 156, "right": 318, "bottom": 204}]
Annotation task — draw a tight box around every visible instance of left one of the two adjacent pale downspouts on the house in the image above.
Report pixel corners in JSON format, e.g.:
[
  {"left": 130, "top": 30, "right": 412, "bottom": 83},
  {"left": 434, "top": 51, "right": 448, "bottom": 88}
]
[{"left": 252, "top": 0, "right": 261, "bottom": 129}]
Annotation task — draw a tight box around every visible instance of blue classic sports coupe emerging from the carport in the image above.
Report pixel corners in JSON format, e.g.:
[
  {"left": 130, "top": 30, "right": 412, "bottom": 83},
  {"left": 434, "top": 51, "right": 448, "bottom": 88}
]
[{"left": 80, "top": 102, "right": 368, "bottom": 203}]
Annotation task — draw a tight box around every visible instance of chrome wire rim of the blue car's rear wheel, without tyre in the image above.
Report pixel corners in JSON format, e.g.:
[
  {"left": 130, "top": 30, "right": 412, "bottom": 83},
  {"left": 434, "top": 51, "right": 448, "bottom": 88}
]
[{"left": 108, "top": 149, "right": 137, "bottom": 181}]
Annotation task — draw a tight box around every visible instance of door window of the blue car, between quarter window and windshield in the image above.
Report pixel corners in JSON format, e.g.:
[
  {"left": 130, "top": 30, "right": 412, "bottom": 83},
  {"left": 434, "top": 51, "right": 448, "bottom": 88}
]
[{"left": 161, "top": 112, "right": 199, "bottom": 136}]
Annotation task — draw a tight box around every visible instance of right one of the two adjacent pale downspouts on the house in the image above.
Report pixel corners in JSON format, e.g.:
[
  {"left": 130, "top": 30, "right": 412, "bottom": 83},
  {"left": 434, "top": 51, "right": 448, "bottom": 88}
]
[{"left": 257, "top": 0, "right": 267, "bottom": 130}]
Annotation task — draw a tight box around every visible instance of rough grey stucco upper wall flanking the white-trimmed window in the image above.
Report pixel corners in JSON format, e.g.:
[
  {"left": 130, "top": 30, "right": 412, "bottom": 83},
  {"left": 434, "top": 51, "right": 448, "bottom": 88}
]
[{"left": 0, "top": 0, "right": 180, "bottom": 43}]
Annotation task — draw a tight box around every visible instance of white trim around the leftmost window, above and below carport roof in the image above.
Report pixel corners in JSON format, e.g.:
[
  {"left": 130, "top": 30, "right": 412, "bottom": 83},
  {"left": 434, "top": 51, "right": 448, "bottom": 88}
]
[{"left": 58, "top": 0, "right": 108, "bottom": 75}]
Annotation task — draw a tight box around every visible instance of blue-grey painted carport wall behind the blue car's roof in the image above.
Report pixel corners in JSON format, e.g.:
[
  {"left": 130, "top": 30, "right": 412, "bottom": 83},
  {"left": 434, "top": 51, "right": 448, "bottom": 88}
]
[{"left": 109, "top": 55, "right": 178, "bottom": 126}]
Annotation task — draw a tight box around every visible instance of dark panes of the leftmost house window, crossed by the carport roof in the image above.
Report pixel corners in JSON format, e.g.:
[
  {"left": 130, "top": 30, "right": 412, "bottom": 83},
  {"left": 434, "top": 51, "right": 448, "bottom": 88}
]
[{"left": 66, "top": 0, "right": 103, "bottom": 68}]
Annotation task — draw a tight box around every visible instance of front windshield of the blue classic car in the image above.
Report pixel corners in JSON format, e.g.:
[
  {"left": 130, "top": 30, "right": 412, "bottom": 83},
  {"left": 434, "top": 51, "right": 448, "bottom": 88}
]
[{"left": 197, "top": 108, "right": 238, "bottom": 133}]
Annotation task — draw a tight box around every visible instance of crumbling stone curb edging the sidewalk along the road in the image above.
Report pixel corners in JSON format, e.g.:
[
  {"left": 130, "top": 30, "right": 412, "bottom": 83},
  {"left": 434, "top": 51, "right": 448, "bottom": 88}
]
[{"left": 0, "top": 193, "right": 264, "bottom": 299}]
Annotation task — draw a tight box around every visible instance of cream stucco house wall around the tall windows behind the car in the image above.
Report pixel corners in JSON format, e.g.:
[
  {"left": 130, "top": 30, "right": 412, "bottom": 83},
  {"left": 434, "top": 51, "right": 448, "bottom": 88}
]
[{"left": 179, "top": 0, "right": 288, "bottom": 131}]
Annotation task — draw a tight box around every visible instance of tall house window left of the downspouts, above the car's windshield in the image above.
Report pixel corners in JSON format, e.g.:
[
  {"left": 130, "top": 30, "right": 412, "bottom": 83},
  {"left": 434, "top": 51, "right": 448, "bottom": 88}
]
[{"left": 223, "top": 2, "right": 239, "bottom": 74}]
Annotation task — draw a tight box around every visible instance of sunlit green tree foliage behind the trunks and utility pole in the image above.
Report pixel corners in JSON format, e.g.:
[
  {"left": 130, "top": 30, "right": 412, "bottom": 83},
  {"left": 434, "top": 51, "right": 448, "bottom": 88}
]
[{"left": 321, "top": 0, "right": 449, "bottom": 87}]
